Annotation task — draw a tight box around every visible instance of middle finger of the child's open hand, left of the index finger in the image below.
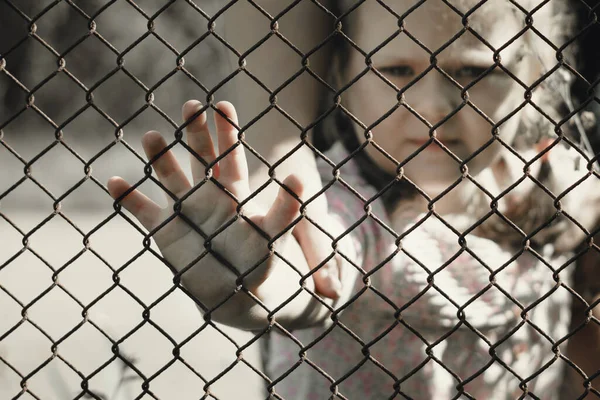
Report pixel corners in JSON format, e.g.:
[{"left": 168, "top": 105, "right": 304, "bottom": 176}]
[{"left": 181, "top": 100, "right": 219, "bottom": 184}]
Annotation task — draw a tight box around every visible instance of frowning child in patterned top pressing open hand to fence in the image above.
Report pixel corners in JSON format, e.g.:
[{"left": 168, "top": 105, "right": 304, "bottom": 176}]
[{"left": 108, "top": 0, "right": 599, "bottom": 399}]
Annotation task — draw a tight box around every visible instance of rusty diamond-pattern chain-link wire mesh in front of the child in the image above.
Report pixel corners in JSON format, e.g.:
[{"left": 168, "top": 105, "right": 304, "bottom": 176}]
[{"left": 0, "top": 0, "right": 600, "bottom": 400}]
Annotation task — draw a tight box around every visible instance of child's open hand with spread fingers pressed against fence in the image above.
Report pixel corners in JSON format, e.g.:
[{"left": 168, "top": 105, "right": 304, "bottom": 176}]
[{"left": 108, "top": 101, "right": 352, "bottom": 329}]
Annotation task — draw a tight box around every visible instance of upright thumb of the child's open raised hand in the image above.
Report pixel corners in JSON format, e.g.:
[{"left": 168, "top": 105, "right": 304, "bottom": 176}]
[{"left": 262, "top": 175, "right": 303, "bottom": 241}]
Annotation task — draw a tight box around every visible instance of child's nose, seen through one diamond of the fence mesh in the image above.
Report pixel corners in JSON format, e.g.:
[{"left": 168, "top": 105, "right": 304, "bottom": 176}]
[{"left": 406, "top": 69, "right": 462, "bottom": 130}]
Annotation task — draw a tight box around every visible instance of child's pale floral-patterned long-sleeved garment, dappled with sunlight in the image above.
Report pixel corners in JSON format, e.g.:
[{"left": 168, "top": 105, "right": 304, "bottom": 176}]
[{"left": 266, "top": 145, "right": 574, "bottom": 400}]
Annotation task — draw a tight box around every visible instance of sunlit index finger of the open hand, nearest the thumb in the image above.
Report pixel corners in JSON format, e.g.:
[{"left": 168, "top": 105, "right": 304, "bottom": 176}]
[{"left": 215, "top": 101, "right": 250, "bottom": 198}]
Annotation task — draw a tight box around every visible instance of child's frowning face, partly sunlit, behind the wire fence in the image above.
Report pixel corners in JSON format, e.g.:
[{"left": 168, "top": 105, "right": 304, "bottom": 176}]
[{"left": 342, "top": 0, "right": 535, "bottom": 194}]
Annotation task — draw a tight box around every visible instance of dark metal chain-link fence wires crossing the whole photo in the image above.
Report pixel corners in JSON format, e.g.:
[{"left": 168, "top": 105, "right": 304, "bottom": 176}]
[{"left": 0, "top": 0, "right": 600, "bottom": 399}]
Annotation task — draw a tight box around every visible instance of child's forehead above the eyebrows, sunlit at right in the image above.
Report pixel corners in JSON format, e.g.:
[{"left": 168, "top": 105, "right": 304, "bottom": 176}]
[{"left": 348, "top": 0, "right": 524, "bottom": 62}]
